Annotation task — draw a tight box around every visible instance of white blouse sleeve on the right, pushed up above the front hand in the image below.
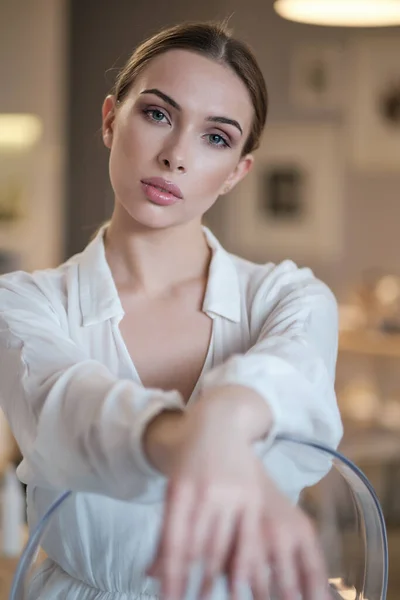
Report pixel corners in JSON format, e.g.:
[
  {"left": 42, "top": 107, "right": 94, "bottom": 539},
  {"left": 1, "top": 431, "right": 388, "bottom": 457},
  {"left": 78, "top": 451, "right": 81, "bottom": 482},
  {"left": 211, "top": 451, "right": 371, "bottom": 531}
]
[{"left": 204, "top": 263, "right": 343, "bottom": 496}]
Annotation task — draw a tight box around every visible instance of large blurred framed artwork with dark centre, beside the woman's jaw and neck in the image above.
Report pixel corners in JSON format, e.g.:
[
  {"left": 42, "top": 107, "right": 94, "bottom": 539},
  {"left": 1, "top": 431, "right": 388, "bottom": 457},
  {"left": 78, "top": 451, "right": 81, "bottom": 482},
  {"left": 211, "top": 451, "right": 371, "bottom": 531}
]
[{"left": 224, "top": 123, "right": 343, "bottom": 262}]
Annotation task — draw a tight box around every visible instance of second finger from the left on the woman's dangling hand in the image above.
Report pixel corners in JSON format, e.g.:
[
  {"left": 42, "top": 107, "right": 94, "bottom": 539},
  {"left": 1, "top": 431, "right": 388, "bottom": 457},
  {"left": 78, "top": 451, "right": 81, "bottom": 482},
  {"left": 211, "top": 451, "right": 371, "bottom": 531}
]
[{"left": 200, "top": 511, "right": 237, "bottom": 599}]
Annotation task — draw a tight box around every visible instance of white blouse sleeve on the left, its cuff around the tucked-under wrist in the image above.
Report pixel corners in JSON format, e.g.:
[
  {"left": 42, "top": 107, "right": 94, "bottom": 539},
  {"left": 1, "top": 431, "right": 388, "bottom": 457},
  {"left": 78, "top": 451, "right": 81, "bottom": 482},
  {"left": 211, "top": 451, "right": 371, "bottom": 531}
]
[{"left": 0, "top": 278, "right": 184, "bottom": 502}]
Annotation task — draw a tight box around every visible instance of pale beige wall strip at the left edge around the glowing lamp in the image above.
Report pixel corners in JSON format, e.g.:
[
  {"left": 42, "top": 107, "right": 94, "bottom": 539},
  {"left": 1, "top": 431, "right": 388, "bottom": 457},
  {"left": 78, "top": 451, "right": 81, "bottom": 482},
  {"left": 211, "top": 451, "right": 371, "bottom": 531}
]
[{"left": 0, "top": 0, "right": 67, "bottom": 269}]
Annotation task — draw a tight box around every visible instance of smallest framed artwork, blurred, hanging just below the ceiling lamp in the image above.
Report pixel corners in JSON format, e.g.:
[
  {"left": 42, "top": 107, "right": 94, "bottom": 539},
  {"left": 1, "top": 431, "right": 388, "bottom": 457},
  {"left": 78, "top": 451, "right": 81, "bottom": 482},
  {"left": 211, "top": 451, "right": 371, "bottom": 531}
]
[{"left": 289, "top": 43, "right": 345, "bottom": 111}]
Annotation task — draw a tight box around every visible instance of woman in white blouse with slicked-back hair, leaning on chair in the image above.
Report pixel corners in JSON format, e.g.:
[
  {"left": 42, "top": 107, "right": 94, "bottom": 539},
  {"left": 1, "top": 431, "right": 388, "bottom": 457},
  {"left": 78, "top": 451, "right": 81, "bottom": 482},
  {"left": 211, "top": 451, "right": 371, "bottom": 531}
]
[{"left": 0, "top": 19, "right": 342, "bottom": 600}]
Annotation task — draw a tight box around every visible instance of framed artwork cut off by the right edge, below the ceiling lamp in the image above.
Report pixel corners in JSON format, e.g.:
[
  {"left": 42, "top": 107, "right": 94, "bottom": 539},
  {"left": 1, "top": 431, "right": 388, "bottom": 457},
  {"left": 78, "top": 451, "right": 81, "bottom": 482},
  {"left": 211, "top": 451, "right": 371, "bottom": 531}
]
[{"left": 347, "top": 36, "right": 400, "bottom": 173}]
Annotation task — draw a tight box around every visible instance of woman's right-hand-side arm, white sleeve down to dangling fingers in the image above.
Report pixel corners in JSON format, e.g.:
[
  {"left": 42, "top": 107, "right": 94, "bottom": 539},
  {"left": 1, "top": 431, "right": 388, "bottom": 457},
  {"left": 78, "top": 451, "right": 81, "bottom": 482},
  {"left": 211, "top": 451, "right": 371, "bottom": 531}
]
[{"left": 141, "top": 272, "right": 341, "bottom": 598}]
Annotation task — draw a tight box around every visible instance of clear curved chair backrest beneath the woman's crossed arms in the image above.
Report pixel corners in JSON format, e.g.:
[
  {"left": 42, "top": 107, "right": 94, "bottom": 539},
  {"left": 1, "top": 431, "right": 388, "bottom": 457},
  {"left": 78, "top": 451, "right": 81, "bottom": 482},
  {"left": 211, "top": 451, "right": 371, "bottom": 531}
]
[{"left": 9, "top": 435, "right": 389, "bottom": 600}]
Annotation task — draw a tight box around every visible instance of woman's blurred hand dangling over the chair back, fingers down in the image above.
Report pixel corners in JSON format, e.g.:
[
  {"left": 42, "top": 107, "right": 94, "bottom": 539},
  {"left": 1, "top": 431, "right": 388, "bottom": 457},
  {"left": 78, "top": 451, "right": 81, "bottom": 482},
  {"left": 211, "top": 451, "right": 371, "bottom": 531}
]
[{"left": 145, "top": 404, "right": 328, "bottom": 600}]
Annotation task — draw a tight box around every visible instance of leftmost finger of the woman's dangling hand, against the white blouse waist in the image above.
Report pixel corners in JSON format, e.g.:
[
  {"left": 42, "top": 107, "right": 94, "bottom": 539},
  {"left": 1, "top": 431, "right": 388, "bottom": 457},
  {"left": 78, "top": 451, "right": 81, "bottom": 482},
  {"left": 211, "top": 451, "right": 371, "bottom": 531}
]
[{"left": 155, "top": 485, "right": 195, "bottom": 600}]
